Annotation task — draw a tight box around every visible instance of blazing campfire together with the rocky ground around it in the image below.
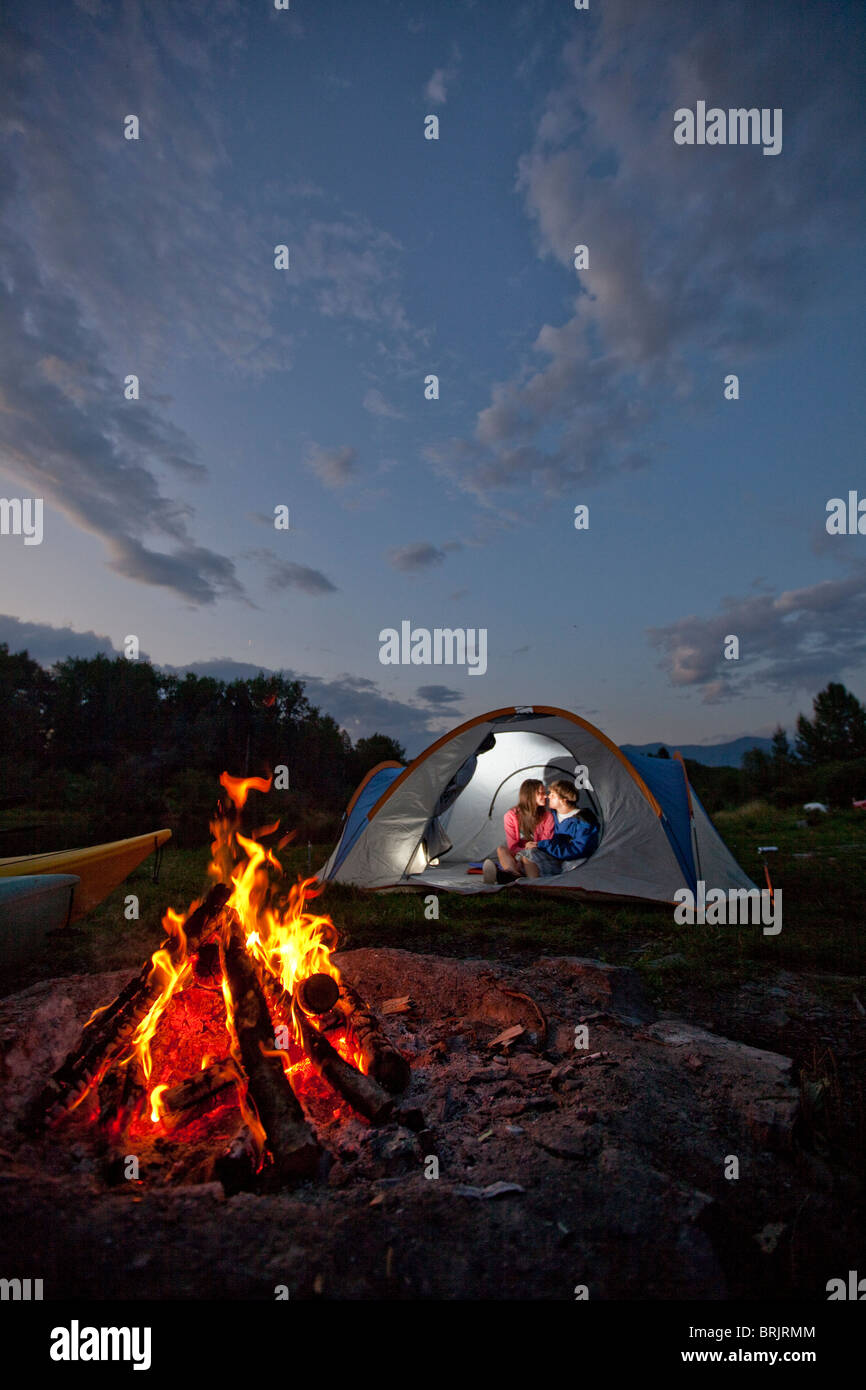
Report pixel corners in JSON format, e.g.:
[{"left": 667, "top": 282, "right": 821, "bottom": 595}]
[{"left": 0, "top": 777, "right": 849, "bottom": 1300}]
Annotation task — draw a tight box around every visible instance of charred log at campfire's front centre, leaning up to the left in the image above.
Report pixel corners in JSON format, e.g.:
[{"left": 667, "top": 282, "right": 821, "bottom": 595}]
[{"left": 220, "top": 913, "right": 321, "bottom": 1180}]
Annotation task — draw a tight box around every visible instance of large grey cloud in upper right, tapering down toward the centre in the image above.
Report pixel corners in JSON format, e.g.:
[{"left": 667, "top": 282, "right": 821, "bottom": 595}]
[{"left": 425, "top": 0, "right": 863, "bottom": 506}]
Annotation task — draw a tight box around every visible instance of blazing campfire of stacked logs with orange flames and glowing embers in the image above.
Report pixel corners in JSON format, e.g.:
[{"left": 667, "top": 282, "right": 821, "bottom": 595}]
[{"left": 38, "top": 773, "right": 414, "bottom": 1193}]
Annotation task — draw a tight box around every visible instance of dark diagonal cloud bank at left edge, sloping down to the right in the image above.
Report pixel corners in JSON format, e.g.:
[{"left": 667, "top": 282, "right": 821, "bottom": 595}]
[{"left": 0, "top": 216, "right": 243, "bottom": 603}]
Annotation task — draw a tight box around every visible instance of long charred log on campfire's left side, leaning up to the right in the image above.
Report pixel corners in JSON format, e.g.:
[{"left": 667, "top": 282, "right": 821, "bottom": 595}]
[{"left": 36, "top": 883, "right": 232, "bottom": 1122}]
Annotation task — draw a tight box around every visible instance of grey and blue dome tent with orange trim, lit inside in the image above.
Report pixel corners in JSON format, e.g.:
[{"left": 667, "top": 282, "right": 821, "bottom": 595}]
[{"left": 318, "top": 705, "right": 756, "bottom": 902}]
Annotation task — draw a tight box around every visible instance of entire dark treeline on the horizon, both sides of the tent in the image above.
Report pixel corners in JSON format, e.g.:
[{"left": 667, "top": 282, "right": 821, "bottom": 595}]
[{"left": 0, "top": 644, "right": 866, "bottom": 856}]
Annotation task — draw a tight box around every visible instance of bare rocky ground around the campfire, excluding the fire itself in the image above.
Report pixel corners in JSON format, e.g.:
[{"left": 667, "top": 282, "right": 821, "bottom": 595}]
[{"left": 0, "top": 949, "right": 865, "bottom": 1300}]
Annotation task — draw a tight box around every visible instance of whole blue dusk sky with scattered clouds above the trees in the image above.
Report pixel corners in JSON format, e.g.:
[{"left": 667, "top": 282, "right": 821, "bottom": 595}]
[{"left": 0, "top": 0, "right": 866, "bottom": 753}]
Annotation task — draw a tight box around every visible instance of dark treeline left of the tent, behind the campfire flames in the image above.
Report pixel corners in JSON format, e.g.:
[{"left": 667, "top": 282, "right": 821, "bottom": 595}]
[{"left": 0, "top": 644, "right": 406, "bottom": 855}]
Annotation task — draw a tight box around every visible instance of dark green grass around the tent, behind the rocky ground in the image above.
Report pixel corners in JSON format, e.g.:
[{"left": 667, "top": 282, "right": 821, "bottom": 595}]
[{"left": 3, "top": 802, "right": 866, "bottom": 1005}]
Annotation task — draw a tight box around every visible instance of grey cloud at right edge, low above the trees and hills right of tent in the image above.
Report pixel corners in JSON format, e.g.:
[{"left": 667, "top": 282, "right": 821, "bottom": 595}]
[{"left": 648, "top": 560, "right": 866, "bottom": 703}]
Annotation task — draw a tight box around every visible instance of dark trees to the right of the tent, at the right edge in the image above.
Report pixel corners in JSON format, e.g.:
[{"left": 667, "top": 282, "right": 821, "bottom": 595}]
[{"left": 656, "top": 681, "right": 866, "bottom": 815}]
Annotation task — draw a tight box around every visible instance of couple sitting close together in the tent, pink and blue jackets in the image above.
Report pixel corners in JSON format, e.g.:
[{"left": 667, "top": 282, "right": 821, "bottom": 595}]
[{"left": 484, "top": 778, "right": 599, "bottom": 883}]
